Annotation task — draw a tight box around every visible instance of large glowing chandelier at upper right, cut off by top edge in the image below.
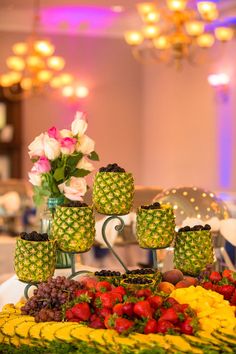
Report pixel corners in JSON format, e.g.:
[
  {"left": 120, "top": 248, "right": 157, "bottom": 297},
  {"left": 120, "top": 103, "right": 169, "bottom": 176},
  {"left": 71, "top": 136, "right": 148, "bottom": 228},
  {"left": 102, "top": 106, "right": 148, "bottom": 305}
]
[{"left": 125, "top": 0, "right": 234, "bottom": 67}]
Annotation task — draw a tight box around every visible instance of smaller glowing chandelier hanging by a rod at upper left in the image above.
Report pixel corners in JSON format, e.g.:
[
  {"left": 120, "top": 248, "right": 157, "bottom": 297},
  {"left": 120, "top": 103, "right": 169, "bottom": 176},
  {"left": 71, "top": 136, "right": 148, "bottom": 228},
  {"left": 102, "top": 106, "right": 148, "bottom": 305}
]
[{"left": 0, "top": 0, "right": 74, "bottom": 100}]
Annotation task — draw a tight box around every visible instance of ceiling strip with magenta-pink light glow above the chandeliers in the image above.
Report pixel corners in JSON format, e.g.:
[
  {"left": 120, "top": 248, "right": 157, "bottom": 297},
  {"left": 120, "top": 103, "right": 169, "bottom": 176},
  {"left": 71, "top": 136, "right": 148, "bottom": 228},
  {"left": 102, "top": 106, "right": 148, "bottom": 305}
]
[{"left": 0, "top": 0, "right": 236, "bottom": 37}]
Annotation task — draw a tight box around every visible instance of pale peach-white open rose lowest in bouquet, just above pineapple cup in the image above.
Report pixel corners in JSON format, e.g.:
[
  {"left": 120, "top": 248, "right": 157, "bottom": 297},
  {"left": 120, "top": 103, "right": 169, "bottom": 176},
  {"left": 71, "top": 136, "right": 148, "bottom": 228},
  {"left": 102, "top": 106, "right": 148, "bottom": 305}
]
[{"left": 58, "top": 177, "right": 87, "bottom": 200}]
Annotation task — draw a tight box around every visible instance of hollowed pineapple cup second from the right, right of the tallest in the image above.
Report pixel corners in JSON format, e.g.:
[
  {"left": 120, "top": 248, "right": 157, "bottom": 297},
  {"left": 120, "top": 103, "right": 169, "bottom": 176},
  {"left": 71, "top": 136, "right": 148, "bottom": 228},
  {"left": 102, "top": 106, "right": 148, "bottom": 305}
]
[{"left": 136, "top": 205, "right": 175, "bottom": 249}]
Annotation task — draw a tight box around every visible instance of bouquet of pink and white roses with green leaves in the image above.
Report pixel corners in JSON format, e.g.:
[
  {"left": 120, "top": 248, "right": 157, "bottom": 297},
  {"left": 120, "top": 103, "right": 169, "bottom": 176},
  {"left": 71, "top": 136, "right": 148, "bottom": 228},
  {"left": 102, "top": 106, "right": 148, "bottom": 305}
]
[{"left": 28, "top": 112, "right": 99, "bottom": 205}]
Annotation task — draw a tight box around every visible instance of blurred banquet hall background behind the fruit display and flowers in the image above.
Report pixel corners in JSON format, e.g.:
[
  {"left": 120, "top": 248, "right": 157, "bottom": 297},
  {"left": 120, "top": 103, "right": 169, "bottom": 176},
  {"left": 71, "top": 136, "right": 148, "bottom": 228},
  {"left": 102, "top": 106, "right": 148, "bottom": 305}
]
[{"left": 0, "top": 0, "right": 236, "bottom": 284}]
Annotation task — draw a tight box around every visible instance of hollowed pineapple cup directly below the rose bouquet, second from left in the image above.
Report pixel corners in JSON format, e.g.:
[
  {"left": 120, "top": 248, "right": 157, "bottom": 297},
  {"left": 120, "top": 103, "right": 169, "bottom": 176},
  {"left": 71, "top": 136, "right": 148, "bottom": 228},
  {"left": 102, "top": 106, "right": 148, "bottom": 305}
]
[{"left": 50, "top": 206, "right": 95, "bottom": 253}]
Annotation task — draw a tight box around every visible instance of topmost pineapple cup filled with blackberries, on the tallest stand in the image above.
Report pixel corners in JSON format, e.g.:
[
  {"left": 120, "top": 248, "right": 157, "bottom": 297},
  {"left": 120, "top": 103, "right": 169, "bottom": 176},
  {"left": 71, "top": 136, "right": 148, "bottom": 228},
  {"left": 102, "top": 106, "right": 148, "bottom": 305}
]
[{"left": 93, "top": 163, "right": 134, "bottom": 215}]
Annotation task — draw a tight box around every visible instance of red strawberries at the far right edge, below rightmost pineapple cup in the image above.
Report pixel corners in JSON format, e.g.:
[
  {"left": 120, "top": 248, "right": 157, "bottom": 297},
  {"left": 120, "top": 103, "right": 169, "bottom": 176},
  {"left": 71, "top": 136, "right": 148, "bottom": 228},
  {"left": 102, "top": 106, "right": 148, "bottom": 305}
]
[{"left": 200, "top": 269, "right": 236, "bottom": 306}]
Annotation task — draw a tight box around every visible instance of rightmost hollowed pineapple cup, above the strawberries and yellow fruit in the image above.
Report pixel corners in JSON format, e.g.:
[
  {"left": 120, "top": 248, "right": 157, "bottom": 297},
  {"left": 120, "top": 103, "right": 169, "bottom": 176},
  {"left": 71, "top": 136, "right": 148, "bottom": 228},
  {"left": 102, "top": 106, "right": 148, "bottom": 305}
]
[{"left": 174, "top": 230, "right": 214, "bottom": 276}]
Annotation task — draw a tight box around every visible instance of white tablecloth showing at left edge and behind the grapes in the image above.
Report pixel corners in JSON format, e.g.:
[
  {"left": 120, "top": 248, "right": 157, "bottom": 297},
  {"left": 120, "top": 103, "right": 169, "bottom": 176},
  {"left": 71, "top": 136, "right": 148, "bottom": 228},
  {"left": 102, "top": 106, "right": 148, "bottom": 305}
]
[{"left": 0, "top": 264, "right": 97, "bottom": 310}]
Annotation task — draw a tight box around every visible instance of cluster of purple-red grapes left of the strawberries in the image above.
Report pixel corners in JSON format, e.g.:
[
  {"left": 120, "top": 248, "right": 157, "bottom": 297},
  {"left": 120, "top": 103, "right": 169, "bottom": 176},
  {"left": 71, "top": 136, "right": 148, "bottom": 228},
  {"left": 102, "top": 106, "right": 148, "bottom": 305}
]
[{"left": 21, "top": 276, "right": 81, "bottom": 322}]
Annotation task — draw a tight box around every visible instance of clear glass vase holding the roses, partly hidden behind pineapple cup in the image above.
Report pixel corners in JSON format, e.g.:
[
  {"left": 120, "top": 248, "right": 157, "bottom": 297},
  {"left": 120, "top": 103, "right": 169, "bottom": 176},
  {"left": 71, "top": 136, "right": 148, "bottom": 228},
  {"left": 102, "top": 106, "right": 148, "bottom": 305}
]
[{"left": 41, "top": 197, "right": 71, "bottom": 269}]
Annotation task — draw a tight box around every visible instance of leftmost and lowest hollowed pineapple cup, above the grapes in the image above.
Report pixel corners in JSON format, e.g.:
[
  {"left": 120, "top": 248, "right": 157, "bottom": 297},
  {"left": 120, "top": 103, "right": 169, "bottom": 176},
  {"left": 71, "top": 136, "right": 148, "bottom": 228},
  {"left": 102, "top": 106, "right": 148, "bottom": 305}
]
[{"left": 14, "top": 238, "right": 56, "bottom": 283}]
